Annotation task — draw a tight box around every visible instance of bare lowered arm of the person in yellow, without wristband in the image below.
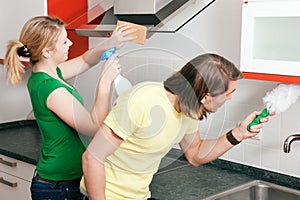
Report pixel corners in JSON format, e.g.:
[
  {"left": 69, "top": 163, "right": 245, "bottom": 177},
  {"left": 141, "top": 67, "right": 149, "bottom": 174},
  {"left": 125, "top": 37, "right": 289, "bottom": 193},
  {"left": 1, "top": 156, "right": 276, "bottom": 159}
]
[{"left": 82, "top": 125, "right": 123, "bottom": 200}]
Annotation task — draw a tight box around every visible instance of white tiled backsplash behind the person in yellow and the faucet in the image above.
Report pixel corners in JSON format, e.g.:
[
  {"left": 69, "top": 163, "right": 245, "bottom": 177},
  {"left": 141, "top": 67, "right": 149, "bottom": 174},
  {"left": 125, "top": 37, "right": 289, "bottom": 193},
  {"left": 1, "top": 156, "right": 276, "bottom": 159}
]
[{"left": 121, "top": 56, "right": 300, "bottom": 178}]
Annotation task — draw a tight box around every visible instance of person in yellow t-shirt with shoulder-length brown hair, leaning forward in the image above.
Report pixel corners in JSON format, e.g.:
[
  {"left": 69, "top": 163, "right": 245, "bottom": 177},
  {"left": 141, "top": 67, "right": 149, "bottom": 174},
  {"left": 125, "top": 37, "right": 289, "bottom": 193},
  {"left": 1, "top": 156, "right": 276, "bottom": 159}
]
[{"left": 81, "top": 54, "right": 274, "bottom": 200}]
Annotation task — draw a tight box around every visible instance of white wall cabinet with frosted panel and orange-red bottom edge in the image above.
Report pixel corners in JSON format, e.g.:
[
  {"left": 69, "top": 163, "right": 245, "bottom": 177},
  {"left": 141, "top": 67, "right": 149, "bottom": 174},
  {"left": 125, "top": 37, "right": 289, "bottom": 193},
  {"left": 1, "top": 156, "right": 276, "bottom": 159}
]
[{"left": 240, "top": 0, "right": 300, "bottom": 79}]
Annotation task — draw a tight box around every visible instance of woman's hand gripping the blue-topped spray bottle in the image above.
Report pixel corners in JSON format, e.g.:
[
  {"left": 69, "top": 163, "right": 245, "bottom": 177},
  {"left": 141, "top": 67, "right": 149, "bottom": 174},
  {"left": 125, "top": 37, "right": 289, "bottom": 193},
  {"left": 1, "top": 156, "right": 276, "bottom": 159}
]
[{"left": 100, "top": 53, "right": 122, "bottom": 83}]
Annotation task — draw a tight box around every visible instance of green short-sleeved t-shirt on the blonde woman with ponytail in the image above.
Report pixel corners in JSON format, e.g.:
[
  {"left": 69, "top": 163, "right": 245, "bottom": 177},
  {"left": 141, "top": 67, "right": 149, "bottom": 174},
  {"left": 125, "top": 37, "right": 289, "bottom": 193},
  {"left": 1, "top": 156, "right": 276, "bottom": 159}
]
[{"left": 27, "top": 67, "right": 85, "bottom": 181}]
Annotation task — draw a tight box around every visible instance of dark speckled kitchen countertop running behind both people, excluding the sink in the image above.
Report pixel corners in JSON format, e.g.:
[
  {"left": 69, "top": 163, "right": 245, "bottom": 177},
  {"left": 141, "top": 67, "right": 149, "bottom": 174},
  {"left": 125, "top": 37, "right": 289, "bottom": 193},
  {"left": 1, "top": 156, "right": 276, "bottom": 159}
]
[{"left": 0, "top": 120, "right": 300, "bottom": 200}]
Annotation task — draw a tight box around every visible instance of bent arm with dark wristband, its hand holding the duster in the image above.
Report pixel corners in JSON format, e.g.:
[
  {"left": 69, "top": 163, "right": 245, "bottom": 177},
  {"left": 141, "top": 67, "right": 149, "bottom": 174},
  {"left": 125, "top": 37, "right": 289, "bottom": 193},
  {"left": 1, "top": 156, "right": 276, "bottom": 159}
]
[{"left": 180, "top": 111, "right": 268, "bottom": 166}]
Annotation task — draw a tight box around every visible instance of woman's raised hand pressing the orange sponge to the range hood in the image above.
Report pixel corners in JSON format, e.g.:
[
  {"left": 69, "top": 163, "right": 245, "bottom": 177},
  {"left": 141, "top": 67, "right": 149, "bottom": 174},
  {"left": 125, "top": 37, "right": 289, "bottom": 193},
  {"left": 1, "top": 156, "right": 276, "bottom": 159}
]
[{"left": 109, "top": 24, "right": 137, "bottom": 49}]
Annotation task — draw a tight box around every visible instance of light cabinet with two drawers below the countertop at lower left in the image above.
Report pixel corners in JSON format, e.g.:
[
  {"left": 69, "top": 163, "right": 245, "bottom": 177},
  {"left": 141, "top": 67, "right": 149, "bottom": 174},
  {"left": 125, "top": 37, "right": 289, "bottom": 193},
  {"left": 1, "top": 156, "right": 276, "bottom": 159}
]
[{"left": 0, "top": 154, "right": 35, "bottom": 200}]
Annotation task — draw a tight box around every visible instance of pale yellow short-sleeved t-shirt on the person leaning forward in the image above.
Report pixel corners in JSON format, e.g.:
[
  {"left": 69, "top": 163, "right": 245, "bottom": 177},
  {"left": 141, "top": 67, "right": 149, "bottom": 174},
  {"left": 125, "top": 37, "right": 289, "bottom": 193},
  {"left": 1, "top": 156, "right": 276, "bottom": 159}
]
[{"left": 81, "top": 82, "right": 198, "bottom": 200}]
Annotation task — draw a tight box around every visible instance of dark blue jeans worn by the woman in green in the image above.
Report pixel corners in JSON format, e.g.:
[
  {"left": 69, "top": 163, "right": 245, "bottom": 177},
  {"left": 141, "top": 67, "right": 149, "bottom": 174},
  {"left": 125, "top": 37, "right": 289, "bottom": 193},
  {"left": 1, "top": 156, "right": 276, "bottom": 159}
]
[{"left": 30, "top": 177, "right": 83, "bottom": 200}]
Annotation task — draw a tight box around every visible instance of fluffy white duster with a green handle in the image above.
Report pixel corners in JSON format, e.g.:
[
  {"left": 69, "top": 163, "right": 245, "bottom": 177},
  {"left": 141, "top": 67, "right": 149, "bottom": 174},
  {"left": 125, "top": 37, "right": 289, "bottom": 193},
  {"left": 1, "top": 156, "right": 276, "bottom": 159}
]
[{"left": 247, "top": 84, "right": 300, "bottom": 131}]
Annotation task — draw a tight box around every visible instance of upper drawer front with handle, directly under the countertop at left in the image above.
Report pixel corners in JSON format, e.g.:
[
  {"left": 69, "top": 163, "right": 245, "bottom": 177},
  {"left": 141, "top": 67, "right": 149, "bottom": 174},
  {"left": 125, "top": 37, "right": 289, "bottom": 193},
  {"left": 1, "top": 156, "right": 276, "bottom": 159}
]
[{"left": 0, "top": 154, "right": 35, "bottom": 181}]
